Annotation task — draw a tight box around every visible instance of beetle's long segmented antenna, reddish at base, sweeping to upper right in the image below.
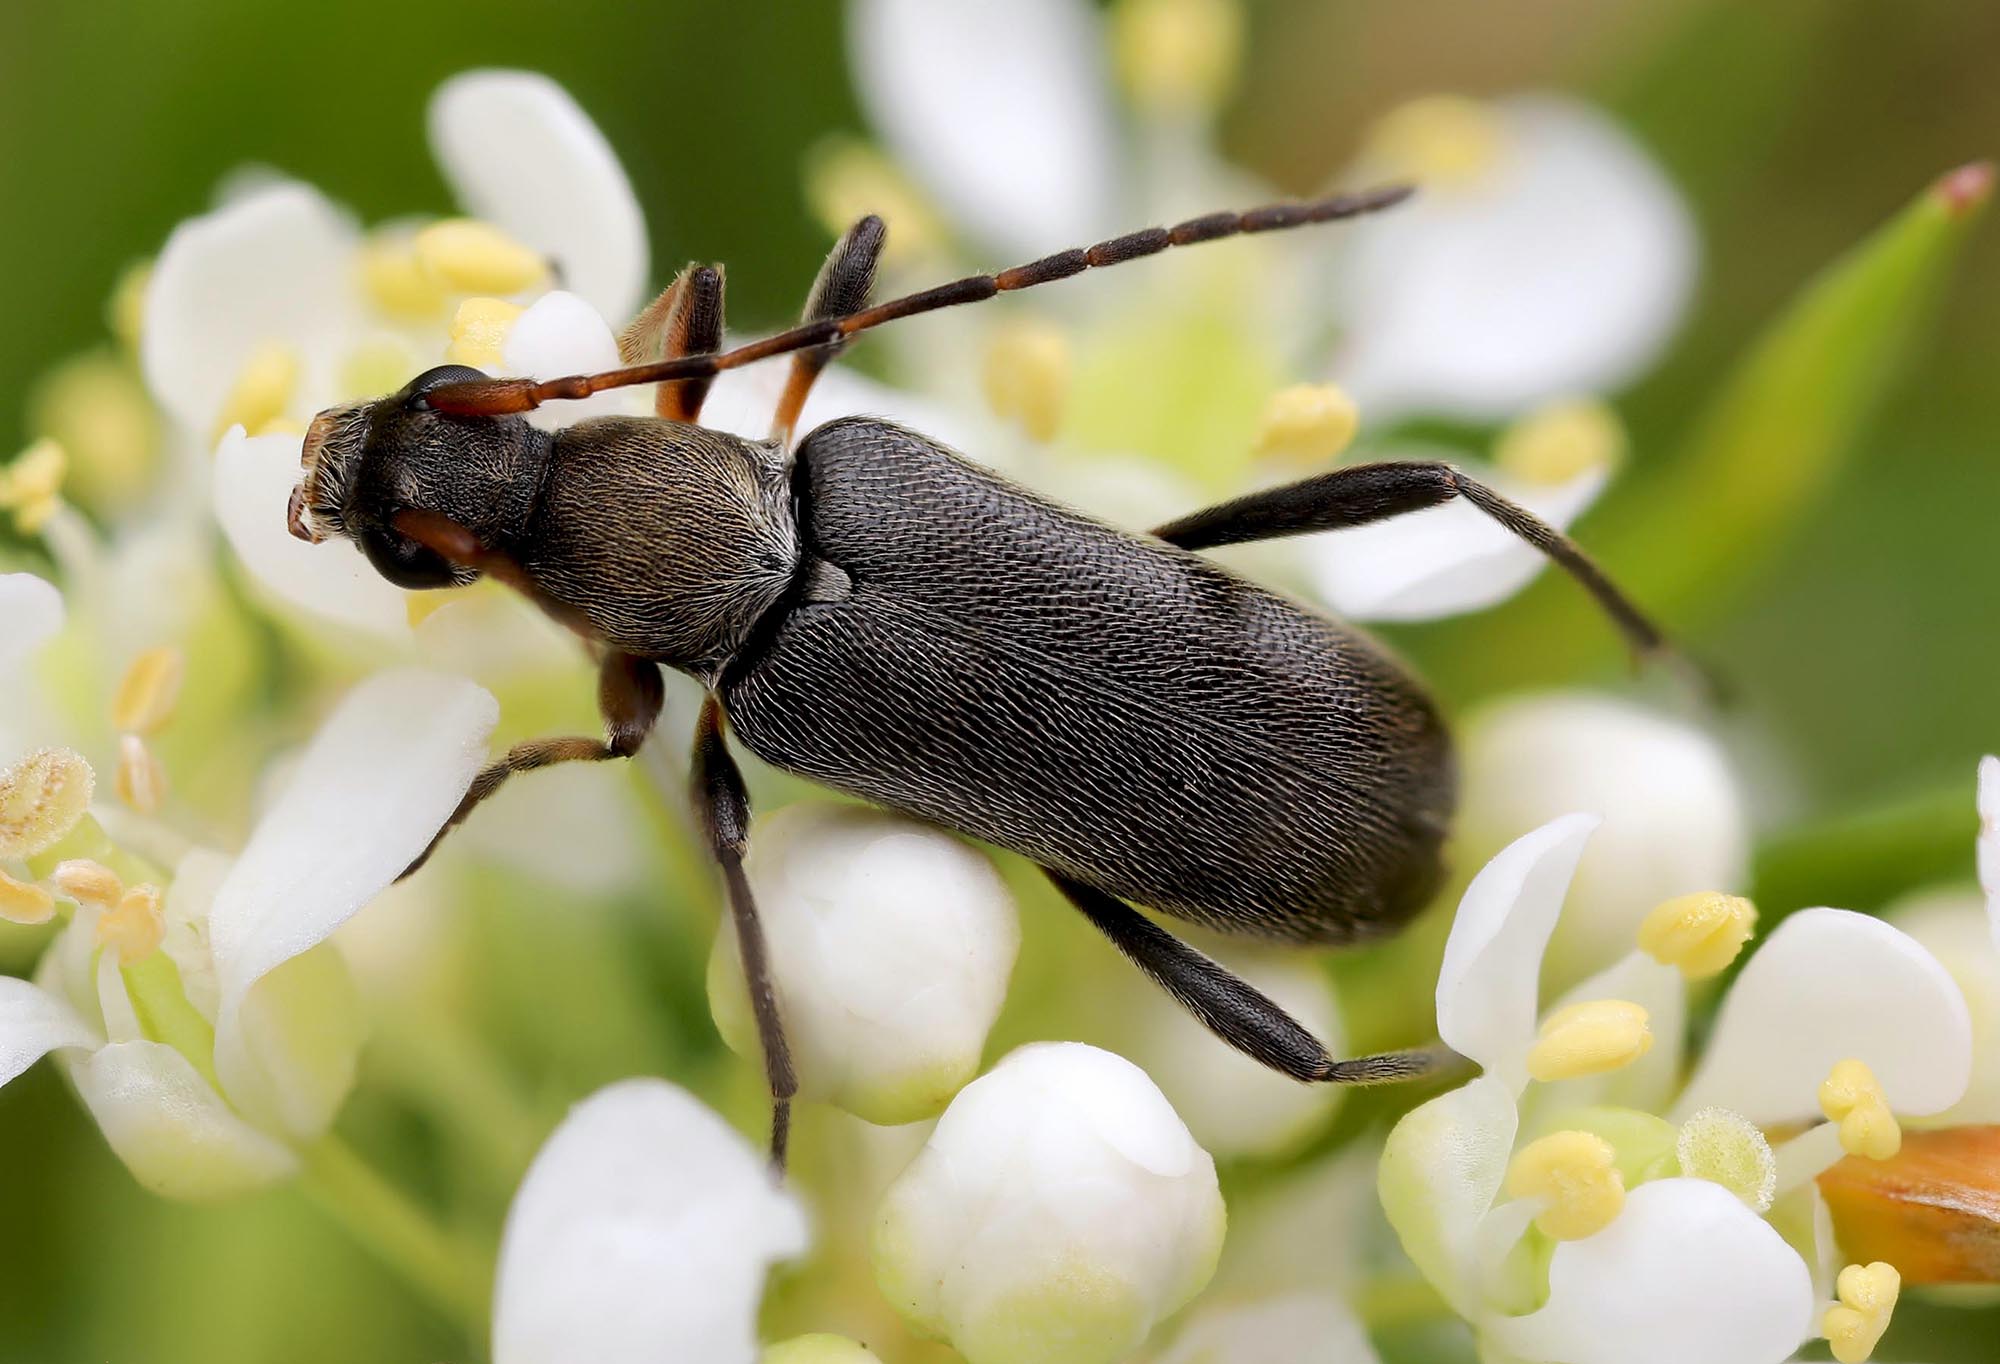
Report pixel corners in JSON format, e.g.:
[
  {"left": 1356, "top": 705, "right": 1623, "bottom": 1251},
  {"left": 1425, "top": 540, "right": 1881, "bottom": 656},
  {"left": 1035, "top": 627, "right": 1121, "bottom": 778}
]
[{"left": 424, "top": 184, "right": 1416, "bottom": 416}]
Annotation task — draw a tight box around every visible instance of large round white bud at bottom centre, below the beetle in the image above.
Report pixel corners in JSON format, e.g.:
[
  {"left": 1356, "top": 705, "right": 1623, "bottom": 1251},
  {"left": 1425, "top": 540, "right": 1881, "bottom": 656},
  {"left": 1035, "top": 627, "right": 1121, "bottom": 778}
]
[{"left": 874, "top": 1042, "right": 1224, "bottom": 1364}]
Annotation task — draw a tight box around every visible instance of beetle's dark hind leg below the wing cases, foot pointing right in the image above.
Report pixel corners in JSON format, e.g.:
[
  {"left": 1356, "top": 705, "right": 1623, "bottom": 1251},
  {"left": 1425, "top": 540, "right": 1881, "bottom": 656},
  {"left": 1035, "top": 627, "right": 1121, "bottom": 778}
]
[{"left": 1042, "top": 868, "right": 1456, "bottom": 1084}]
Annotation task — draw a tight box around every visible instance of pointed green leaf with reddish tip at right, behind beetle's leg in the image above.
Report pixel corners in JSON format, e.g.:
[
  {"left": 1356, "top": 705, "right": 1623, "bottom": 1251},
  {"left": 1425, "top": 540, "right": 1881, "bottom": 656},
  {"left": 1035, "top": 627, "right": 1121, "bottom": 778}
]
[{"left": 1440, "top": 164, "right": 1994, "bottom": 690}]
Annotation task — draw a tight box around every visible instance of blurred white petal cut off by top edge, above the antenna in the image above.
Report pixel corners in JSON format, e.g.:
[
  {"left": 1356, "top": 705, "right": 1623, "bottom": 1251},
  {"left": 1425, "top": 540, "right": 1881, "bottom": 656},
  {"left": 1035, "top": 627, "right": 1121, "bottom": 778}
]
[{"left": 848, "top": 0, "right": 1120, "bottom": 258}]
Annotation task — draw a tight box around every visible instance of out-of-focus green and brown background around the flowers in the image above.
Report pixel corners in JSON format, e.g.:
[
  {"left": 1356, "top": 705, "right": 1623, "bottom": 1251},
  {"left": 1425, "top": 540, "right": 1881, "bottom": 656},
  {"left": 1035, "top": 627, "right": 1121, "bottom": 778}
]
[{"left": 0, "top": 0, "right": 2000, "bottom": 1360}]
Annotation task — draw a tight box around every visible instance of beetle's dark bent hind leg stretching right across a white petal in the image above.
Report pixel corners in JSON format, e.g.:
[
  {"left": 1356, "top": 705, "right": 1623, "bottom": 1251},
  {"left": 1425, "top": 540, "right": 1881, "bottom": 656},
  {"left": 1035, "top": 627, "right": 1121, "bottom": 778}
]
[{"left": 1152, "top": 460, "right": 1666, "bottom": 658}]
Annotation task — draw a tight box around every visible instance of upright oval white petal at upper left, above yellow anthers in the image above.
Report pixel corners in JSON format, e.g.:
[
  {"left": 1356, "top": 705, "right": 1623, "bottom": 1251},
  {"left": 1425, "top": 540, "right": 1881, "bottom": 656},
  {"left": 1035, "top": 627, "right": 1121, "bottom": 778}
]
[{"left": 430, "top": 70, "right": 648, "bottom": 320}]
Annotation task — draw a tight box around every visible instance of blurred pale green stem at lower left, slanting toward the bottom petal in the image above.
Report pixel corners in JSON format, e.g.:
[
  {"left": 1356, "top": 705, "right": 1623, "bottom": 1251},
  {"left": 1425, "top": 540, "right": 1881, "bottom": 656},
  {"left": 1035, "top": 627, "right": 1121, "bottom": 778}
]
[{"left": 300, "top": 1136, "right": 492, "bottom": 1340}]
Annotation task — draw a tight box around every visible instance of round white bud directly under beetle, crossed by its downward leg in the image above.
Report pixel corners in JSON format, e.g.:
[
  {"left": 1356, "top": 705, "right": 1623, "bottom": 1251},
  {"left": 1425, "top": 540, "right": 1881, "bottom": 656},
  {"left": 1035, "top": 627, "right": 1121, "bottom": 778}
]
[{"left": 708, "top": 802, "right": 1020, "bottom": 1124}]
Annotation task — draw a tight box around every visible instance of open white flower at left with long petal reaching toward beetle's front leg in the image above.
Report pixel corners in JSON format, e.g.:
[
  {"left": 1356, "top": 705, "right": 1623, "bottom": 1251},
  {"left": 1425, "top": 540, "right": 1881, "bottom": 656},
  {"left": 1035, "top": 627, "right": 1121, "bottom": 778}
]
[{"left": 0, "top": 672, "right": 496, "bottom": 1198}]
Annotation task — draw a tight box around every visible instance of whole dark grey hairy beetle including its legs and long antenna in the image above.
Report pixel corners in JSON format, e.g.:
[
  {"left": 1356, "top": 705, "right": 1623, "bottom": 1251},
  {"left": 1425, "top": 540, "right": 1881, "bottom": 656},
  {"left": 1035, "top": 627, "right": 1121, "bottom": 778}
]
[{"left": 290, "top": 186, "right": 1662, "bottom": 1168}]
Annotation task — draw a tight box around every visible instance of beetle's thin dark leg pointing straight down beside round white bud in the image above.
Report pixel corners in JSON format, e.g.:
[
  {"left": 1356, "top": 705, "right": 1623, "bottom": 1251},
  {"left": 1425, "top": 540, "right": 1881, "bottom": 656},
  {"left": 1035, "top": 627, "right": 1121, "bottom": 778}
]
[{"left": 690, "top": 696, "right": 798, "bottom": 1174}]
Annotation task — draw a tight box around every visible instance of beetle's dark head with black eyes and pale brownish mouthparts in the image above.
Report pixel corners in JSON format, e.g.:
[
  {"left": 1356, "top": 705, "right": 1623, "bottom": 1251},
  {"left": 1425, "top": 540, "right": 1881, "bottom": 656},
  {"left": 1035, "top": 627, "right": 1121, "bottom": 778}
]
[{"left": 288, "top": 364, "right": 548, "bottom": 588}]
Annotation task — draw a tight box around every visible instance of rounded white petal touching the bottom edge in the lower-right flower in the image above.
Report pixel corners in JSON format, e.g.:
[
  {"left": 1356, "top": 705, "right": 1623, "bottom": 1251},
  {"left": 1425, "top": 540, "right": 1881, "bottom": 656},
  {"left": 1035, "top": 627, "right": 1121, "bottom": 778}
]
[{"left": 1490, "top": 1178, "right": 1816, "bottom": 1364}]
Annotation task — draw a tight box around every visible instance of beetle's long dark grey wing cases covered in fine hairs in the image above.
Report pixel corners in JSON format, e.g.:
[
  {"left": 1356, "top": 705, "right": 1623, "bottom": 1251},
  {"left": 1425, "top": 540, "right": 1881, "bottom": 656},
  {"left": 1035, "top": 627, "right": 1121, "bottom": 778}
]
[{"left": 724, "top": 418, "right": 1452, "bottom": 942}]
